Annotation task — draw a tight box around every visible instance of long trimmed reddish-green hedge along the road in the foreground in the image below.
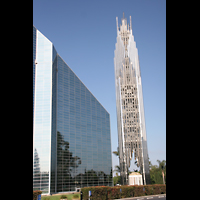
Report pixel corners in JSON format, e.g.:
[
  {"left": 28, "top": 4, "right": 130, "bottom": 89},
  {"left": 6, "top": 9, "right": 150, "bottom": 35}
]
[{"left": 81, "top": 184, "right": 166, "bottom": 200}]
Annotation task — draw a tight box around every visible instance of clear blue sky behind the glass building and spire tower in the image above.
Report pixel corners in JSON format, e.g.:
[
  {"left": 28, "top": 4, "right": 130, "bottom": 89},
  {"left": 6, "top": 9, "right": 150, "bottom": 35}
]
[{"left": 33, "top": 0, "right": 166, "bottom": 173}]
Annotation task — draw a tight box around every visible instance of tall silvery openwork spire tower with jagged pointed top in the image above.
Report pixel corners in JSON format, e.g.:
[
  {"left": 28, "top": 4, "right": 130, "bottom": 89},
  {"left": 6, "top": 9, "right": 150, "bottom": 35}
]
[{"left": 114, "top": 13, "right": 150, "bottom": 185}]
